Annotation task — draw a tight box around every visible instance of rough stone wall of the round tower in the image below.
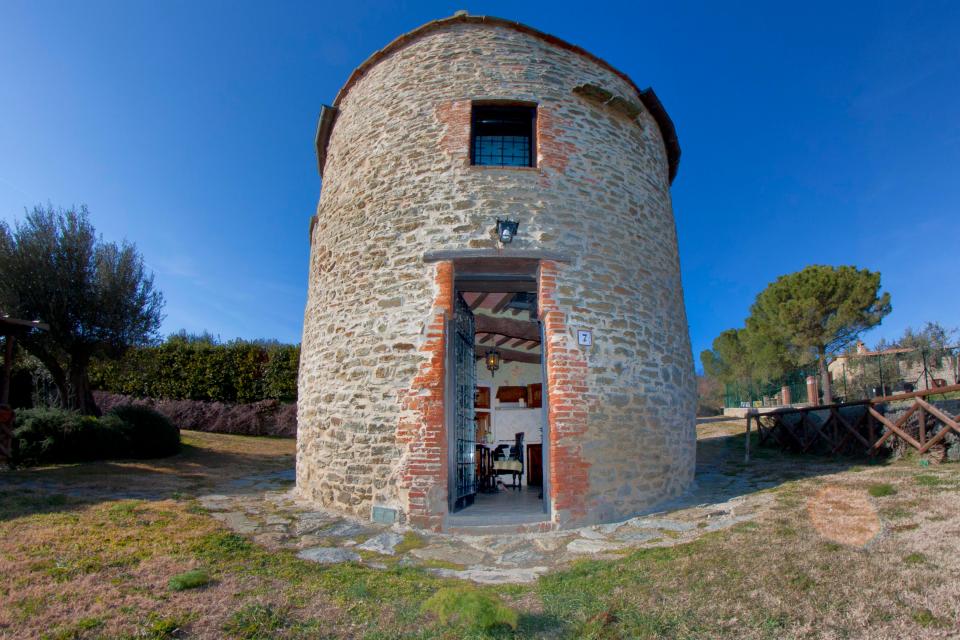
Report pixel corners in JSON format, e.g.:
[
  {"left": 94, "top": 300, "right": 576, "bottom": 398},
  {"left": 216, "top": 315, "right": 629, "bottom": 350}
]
[{"left": 297, "top": 24, "right": 696, "bottom": 526}]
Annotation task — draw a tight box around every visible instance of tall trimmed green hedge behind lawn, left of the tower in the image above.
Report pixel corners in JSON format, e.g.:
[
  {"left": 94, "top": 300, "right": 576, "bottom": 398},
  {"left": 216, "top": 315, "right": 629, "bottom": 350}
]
[{"left": 90, "top": 336, "right": 300, "bottom": 403}]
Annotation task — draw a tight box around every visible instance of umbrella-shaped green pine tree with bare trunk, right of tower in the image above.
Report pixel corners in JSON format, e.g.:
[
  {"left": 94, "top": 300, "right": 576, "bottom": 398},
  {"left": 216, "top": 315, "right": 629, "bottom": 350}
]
[{"left": 747, "top": 265, "right": 891, "bottom": 404}]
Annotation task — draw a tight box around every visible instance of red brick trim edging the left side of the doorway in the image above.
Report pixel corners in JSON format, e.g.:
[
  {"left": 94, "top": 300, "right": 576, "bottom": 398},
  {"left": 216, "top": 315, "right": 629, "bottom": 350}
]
[{"left": 397, "top": 260, "right": 453, "bottom": 531}]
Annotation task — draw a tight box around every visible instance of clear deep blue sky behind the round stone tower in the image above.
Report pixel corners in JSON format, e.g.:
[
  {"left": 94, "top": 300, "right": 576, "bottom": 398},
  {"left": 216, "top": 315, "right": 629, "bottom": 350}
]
[{"left": 0, "top": 0, "right": 960, "bottom": 366}]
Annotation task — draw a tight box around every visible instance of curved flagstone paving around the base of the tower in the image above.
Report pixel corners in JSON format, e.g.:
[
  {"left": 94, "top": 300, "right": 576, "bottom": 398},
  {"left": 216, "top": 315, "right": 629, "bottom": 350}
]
[{"left": 199, "top": 428, "right": 831, "bottom": 583}]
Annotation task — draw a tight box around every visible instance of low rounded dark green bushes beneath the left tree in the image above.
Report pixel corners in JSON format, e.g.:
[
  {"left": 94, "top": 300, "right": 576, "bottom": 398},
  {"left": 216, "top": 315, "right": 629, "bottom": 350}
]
[{"left": 13, "top": 407, "right": 180, "bottom": 466}]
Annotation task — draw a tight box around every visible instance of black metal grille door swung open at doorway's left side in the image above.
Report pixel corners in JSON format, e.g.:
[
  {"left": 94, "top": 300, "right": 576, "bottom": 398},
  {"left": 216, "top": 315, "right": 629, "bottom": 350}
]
[{"left": 453, "top": 293, "right": 477, "bottom": 511}]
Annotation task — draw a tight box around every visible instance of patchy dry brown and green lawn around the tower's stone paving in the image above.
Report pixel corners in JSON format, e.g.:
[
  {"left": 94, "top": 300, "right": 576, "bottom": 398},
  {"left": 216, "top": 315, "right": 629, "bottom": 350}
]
[{"left": 0, "top": 424, "right": 960, "bottom": 640}]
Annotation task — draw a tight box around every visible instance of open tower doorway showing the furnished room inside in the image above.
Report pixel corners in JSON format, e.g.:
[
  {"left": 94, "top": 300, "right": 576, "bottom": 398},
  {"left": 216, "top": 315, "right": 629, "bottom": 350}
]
[{"left": 448, "top": 275, "right": 549, "bottom": 526}]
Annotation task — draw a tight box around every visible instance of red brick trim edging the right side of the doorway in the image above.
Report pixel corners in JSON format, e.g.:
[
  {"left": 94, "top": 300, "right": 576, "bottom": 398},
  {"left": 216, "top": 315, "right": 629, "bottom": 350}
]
[{"left": 538, "top": 260, "right": 590, "bottom": 525}]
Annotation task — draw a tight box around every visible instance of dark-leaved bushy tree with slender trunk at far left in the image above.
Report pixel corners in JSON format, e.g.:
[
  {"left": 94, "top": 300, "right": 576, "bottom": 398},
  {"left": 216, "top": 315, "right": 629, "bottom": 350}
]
[{"left": 0, "top": 206, "right": 163, "bottom": 414}]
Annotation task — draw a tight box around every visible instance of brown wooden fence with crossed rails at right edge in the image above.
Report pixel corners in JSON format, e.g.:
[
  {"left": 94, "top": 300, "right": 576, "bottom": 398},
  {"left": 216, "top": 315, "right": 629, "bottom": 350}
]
[{"left": 745, "top": 385, "right": 960, "bottom": 461}]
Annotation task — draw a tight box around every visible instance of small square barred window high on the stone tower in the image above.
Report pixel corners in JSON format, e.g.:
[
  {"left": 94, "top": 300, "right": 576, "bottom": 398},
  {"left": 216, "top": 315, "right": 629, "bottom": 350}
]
[{"left": 470, "top": 104, "right": 537, "bottom": 167}]
